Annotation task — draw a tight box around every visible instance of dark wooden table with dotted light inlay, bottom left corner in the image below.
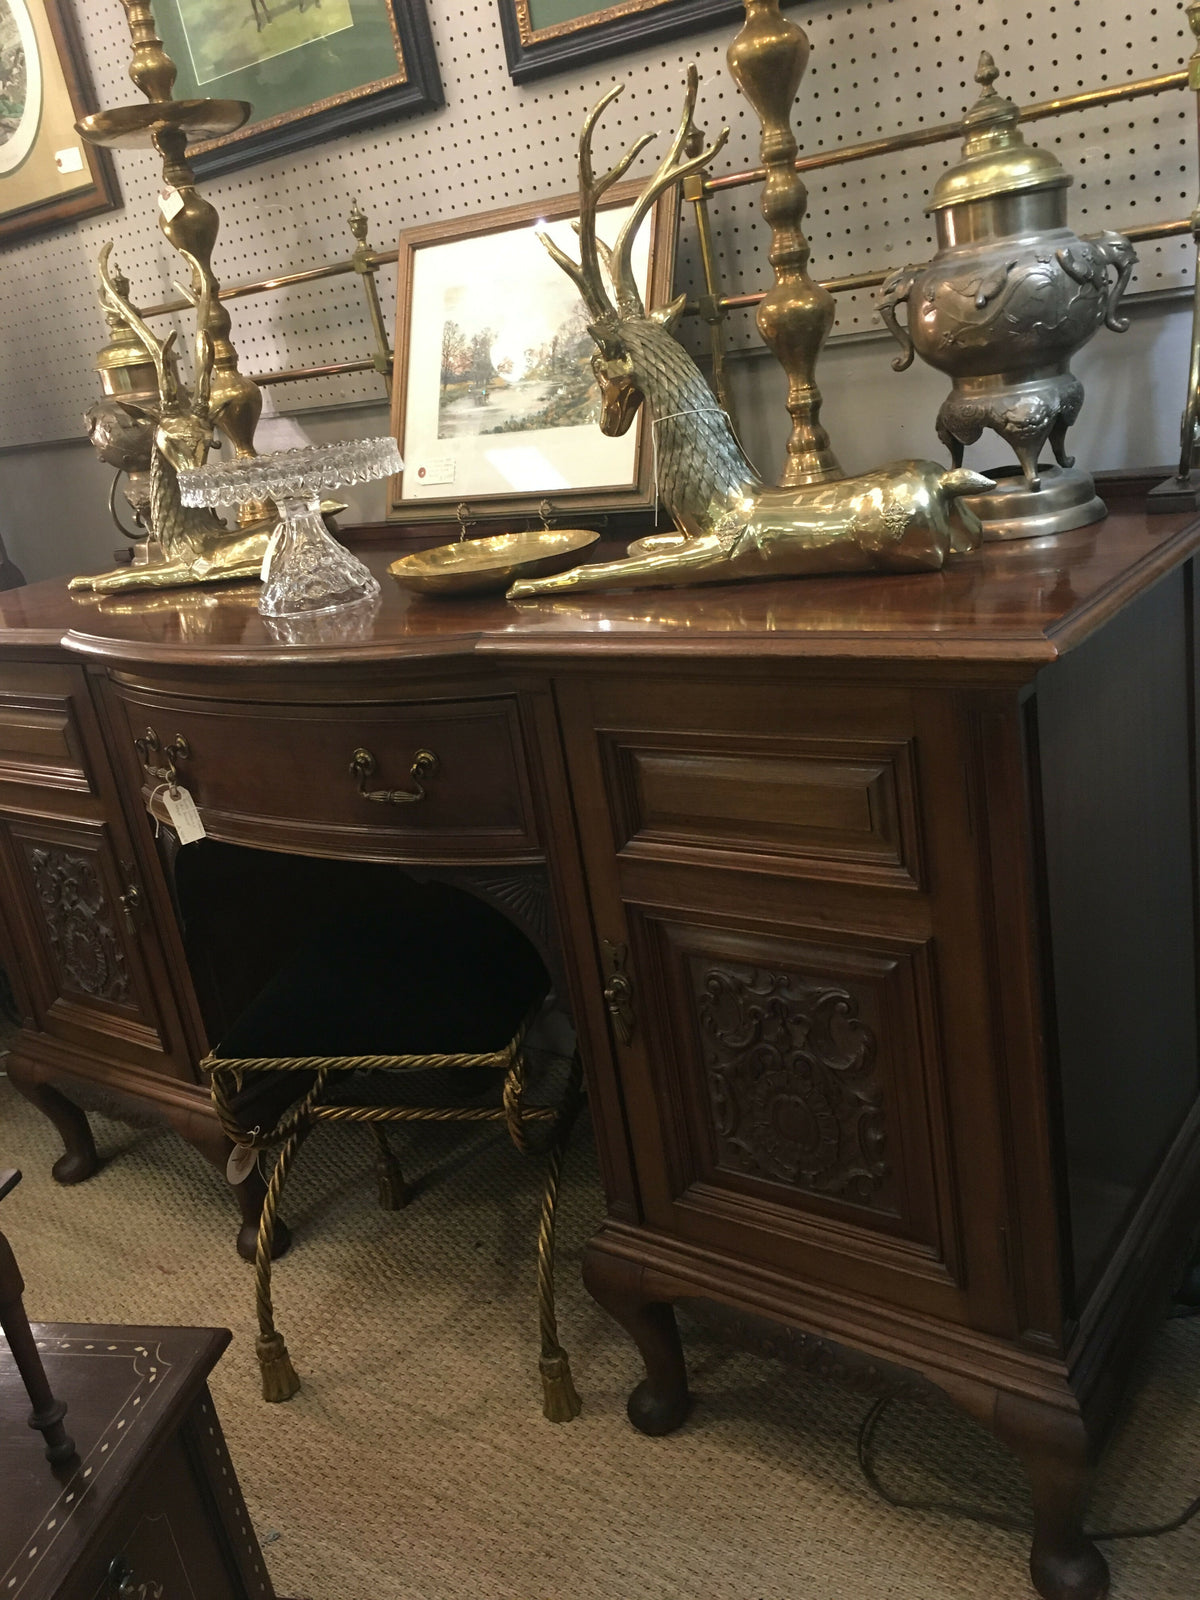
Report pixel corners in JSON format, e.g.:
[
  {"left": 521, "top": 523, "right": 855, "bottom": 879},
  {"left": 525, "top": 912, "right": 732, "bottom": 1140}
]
[{"left": 0, "top": 1323, "right": 275, "bottom": 1600}]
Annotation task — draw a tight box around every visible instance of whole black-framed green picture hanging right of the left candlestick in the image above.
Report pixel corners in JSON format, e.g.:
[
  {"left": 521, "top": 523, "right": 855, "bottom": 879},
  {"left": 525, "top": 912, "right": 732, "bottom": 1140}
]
[{"left": 155, "top": 0, "right": 443, "bottom": 178}]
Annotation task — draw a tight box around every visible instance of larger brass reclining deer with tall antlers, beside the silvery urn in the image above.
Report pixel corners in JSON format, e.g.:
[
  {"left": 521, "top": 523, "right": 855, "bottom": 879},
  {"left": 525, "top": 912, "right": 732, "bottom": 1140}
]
[{"left": 509, "top": 66, "right": 992, "bottom": 600}]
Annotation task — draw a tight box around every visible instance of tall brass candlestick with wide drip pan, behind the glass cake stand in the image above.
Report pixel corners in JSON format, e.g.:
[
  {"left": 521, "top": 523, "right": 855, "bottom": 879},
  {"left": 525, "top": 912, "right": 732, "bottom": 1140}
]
[{"left": 77, "top": 0, "right": 274, "bottom": 526}]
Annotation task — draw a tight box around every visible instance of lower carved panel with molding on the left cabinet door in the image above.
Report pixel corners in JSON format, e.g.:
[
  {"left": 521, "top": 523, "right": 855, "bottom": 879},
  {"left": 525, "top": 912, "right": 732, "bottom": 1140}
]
[{"left": 0, "top": 816, "right": 190, "bottom": 1078}]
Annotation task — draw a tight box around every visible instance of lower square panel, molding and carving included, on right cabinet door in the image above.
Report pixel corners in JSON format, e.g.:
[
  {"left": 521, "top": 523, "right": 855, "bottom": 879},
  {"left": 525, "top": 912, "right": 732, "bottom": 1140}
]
[{"left": 630, "top": 909, "right": 962, "bottom": 1286}]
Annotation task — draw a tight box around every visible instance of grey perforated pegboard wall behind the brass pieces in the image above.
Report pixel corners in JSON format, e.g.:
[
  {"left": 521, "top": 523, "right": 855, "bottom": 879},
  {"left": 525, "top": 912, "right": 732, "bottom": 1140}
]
[{"left": 0, "top": 0, "right": 1197, "bottom": 448}]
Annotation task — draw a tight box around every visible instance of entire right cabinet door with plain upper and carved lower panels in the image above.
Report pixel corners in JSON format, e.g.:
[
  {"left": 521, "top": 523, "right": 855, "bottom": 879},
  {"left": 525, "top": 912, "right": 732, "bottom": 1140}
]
[{"left": 563, "top": 678, "right": 1011, "bottom": 1330}]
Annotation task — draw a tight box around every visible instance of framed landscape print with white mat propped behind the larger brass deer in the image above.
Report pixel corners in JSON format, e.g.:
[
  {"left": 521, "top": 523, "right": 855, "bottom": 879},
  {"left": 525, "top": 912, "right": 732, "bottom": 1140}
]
[{"left": 387, "top": 184, "right": 678, "bottom": 522}]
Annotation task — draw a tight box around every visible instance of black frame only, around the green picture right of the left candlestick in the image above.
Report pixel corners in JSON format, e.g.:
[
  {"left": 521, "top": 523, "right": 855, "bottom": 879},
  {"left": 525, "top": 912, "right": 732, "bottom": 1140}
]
[{"left": 160, "top": 0, "right": 445, "bottom": 178}]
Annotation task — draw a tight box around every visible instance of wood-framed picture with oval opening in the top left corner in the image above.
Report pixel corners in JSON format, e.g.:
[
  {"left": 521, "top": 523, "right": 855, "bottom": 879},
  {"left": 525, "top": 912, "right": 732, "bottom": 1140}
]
[{"left": 0, "top": 0, "right": 120, "bottom": 243}]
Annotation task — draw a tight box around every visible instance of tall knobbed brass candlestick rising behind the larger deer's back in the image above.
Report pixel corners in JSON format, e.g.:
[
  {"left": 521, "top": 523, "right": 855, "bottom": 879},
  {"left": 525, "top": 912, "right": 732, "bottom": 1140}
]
[{"left": 728, "top": 0, "right": 845, "bottom": 488}]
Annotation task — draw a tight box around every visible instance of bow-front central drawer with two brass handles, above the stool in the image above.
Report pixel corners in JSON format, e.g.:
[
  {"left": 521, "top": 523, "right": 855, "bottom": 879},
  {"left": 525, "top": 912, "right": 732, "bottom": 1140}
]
[{"left": 116, "top": 696, "right": 536, "bottom": 858}]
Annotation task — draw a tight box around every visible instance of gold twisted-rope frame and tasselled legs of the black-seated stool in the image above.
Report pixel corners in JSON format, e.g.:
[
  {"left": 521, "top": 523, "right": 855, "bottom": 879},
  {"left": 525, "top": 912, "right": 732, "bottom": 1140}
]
[{"left": 200, "top": 1013, "right": 582, "bottom": 1422}]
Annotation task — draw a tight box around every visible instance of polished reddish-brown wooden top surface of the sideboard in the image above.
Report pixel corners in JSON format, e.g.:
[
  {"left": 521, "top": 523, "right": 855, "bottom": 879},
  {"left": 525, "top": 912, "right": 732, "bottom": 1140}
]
[{"left": 0, "top": 499, "right": 1200, "bottom": 675}]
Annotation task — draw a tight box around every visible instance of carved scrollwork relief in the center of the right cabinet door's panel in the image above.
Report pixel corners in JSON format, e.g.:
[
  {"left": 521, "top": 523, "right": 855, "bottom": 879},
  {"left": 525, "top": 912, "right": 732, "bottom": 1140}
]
[{"left": 688, "top": 955, "right": 894, "bottom": 1211}]
